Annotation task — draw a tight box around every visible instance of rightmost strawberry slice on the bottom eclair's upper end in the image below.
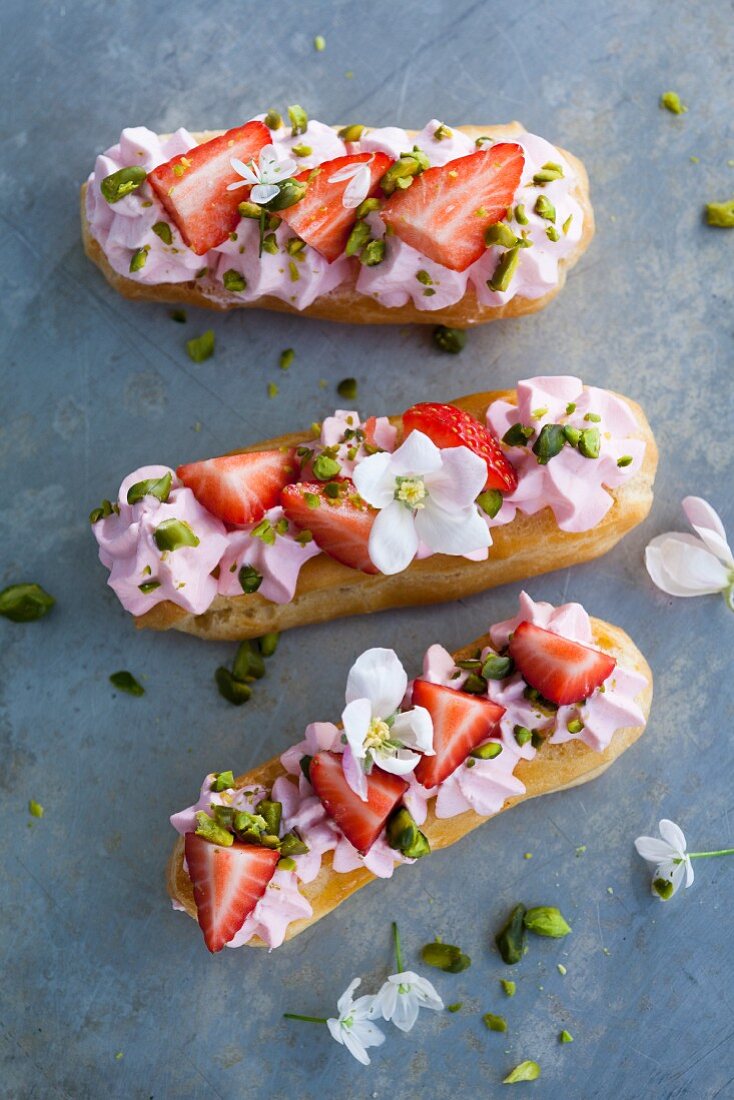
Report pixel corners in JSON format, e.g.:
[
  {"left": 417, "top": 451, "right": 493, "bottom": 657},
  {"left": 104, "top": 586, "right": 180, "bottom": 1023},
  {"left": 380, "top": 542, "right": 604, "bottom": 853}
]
[{"left": 510, "top": 623, "right": 616, "bottom": 706}]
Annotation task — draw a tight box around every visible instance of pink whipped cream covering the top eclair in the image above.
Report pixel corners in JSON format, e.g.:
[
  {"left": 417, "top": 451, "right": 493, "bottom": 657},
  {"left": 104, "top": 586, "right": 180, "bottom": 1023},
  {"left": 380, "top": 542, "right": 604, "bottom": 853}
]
[{"left": 87, "top": 114, "right": 583, "bottom": 310}]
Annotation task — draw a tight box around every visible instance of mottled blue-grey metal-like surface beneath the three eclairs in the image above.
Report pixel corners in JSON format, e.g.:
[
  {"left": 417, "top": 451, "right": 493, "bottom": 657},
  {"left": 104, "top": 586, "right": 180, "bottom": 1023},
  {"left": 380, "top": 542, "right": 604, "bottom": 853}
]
[{"left": 0, "top": 0, "right": 734, "bottom": 1100}]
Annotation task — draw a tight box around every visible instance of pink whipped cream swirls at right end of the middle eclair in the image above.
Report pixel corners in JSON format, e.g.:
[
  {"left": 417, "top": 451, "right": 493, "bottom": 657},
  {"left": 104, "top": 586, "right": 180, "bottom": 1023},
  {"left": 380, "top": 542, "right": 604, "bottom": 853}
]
[{"left": 486, "top": 375, "right": 645, "bottom": 531}]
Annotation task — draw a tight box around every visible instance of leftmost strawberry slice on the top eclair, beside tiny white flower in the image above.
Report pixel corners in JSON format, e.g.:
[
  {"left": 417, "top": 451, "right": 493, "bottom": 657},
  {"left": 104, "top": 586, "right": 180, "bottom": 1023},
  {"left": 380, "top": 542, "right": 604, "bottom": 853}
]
[{"left": 147, "top": 122, "right": 271, "bottom": 256}]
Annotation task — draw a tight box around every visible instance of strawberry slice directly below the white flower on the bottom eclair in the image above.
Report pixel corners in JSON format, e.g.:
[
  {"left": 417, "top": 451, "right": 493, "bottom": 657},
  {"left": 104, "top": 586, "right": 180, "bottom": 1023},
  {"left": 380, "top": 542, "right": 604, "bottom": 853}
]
[{"left": 308, "top": 752, "right": 408, "bottom": 856}]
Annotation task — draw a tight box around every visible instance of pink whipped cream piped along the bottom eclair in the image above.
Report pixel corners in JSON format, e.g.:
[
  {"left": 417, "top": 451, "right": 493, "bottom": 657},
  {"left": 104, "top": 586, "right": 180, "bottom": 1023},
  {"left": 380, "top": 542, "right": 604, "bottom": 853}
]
[{"left": 171, "top": 592, "right": 646, "bottom": 948}]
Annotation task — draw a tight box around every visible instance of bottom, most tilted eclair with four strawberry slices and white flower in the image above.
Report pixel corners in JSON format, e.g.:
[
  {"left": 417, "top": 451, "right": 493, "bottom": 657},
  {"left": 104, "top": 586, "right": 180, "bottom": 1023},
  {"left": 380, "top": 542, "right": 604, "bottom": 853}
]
[{"left": 167, "top": 593, "right": 653, "bottom": 952}]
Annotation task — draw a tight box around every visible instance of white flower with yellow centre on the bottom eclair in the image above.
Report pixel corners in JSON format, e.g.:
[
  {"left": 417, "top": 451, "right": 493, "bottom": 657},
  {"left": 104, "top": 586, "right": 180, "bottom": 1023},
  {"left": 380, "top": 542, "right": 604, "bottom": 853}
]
[{"left": 341, "top": 649, "right": 434, "bottom": 801}]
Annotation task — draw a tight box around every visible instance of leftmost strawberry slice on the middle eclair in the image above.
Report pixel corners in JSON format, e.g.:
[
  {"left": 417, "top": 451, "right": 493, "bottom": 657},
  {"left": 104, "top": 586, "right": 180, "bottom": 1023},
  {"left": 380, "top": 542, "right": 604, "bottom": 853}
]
[{"left": 176, "top": 450, "right": 298, "bottom": 525}]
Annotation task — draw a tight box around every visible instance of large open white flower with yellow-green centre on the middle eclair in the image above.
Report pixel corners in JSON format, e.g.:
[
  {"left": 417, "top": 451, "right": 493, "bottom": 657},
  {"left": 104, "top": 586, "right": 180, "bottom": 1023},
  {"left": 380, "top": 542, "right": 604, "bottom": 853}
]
[{"left": 354, "top": 431, "right": 492, "bottom": 574}]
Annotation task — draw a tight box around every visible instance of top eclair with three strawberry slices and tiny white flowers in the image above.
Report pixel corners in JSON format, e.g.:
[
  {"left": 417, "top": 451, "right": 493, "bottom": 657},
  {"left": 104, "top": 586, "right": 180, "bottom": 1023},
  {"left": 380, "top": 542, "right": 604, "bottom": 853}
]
[{"left": 81, "top": 107, "right": 594, "bottom": 327}]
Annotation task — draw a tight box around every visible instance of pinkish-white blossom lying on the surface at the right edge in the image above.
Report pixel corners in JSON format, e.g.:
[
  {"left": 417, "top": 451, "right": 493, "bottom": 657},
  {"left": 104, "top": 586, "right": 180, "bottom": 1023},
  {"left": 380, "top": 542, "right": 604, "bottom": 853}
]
[{"left": 645, "top": 496, "right": 734, "bottom": 611}]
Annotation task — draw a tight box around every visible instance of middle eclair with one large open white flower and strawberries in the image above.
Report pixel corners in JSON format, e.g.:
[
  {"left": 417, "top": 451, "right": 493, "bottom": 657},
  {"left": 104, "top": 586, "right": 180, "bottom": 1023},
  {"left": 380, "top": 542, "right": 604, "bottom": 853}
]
[{"left": 90, "top": 375, "right": 657, "bottom": 640}]
